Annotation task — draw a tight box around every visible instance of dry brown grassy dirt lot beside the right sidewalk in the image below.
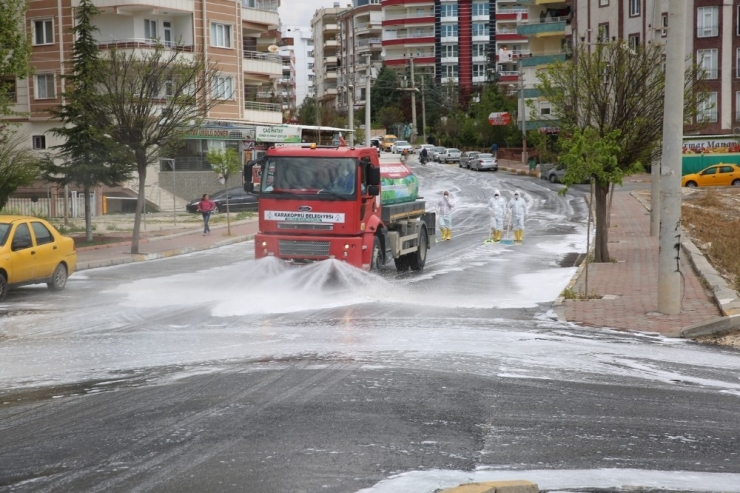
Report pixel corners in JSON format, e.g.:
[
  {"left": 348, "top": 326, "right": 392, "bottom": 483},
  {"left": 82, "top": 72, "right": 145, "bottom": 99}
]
[{"left": 639, "top": 187, "right": 740, "bottom": 348}]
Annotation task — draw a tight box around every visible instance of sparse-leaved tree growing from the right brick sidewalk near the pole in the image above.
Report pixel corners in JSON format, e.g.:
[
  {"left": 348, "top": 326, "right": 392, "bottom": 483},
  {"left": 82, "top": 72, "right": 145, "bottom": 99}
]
[{"left": 536, "top": 40, "right": 706, "bottom": 262}]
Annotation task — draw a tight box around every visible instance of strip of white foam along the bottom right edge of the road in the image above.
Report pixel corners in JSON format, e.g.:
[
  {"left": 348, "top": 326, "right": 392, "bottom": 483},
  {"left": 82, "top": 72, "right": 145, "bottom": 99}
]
[{"left": 358, "top": 468, "right": 740, "bottom": 493}]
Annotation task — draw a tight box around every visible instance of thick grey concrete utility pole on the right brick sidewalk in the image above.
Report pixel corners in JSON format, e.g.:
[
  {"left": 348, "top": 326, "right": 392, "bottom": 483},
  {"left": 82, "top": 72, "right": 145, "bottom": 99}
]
[{"left": 658, "top": 2, "right": 686, "bottom": 315}]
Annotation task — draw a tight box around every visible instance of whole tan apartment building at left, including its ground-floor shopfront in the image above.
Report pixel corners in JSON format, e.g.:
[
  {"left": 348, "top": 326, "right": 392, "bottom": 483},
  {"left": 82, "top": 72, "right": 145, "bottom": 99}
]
[{"left": 11, "top": 0, "right": 283, "bottom": 211}]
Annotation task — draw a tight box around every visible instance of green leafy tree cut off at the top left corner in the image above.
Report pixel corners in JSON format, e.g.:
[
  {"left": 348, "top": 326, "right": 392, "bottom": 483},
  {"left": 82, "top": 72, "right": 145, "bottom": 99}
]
[{"left": 0, "top": 0, "right": 31, "bottom": 122}]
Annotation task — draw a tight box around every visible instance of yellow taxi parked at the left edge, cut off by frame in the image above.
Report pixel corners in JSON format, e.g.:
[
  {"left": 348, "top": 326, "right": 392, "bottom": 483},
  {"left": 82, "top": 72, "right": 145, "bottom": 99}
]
[{"left": 0, "top": 216, "right": 77, "bottom": 300}]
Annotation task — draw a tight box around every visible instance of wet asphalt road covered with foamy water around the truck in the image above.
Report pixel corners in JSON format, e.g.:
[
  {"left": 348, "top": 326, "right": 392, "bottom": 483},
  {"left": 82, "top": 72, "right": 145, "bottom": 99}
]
[{"left": 0, "top": 159, "right": 740, "bottom": 492}]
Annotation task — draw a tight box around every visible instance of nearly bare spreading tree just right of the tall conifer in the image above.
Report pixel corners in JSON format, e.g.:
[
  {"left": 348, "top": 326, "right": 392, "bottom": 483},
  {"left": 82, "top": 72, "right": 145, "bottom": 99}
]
[{"left": 95, "top": 44, "right": 221, "bottom": 254}]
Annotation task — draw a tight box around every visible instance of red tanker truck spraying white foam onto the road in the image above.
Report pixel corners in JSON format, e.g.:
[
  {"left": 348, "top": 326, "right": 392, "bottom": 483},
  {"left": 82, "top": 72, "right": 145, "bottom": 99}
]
[{"left": 244, "top": 144, "right": 436, "bottom": 271}]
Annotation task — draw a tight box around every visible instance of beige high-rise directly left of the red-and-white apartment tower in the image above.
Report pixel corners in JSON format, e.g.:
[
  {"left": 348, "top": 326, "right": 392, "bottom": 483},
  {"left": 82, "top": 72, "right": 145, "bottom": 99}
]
[{"left": 337, "top": 0, "right": 383, "bottom": 113}]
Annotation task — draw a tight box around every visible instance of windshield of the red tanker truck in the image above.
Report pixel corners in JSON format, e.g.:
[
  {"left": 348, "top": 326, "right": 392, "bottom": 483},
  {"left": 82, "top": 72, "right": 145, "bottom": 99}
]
[{"left": 260, "top": 157, "right": 357, "bottom": 197}]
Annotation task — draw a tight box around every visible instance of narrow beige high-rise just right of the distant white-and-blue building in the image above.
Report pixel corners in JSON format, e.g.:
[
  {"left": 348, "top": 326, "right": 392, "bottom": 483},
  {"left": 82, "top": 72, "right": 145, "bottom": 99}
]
[{"left": 311, "top": 2, "right": 346, "bottom": 109}]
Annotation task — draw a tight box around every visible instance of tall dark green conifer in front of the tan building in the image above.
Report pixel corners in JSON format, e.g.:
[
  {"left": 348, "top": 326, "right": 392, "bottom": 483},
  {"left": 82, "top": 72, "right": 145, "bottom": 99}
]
[{"left": 41, "top": 0, "right": 133, "bottom": 241}]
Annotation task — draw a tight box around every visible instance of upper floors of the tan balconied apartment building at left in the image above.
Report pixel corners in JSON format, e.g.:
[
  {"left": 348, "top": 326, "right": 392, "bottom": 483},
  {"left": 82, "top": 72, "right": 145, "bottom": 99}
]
[{"left": 9, "top": 0, "right": 282, "bottom": 153}]
